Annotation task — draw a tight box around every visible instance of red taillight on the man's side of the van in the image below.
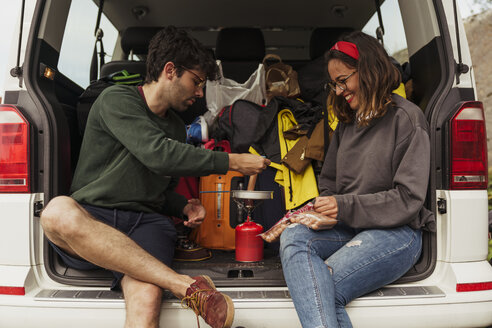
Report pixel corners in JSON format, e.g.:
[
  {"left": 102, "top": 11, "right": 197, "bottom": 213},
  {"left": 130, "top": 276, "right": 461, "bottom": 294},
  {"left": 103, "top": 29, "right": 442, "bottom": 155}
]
[{"left": 0, "top": 105, "right": 30, "bottom": 193}]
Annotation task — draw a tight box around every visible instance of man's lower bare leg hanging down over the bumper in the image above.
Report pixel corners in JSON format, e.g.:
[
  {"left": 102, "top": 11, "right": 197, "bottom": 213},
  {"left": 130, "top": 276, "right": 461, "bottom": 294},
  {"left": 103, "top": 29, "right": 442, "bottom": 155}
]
[{"left": 121, "top": 276, "right": 162, "bottom": 328}]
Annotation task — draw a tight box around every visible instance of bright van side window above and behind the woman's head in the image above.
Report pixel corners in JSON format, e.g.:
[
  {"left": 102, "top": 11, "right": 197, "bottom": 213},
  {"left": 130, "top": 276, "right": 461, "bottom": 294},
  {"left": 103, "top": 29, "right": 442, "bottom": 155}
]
[{"left": 362, "top": 0, "right": 408, "bottom": 64}]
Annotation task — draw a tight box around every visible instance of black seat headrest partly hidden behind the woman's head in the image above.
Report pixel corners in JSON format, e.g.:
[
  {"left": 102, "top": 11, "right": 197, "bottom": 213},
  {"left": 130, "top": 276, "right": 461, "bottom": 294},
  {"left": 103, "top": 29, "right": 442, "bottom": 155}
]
[{"left": 309, "top": 27, "right": 354, "bottom": 59}]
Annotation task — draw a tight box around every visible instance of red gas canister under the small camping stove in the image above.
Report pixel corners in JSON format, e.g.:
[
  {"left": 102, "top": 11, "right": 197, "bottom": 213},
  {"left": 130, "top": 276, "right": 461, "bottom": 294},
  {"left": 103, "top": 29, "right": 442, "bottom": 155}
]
[{"left": 236, "top": 220, "right": 263, "bottom": 262}]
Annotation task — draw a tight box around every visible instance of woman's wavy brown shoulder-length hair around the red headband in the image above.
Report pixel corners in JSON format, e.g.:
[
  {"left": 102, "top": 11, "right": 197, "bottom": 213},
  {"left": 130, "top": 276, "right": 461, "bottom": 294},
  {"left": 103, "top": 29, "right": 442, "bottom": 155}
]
[{"left": 325, "top": 32, "right": 401, "bottom": 126}]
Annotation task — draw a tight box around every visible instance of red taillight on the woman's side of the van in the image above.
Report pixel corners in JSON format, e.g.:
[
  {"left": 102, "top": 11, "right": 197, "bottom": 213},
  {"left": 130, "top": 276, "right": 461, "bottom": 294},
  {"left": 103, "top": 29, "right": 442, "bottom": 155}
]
[{"left": 450, "top": 101, "right": 488, "bottom": 189}]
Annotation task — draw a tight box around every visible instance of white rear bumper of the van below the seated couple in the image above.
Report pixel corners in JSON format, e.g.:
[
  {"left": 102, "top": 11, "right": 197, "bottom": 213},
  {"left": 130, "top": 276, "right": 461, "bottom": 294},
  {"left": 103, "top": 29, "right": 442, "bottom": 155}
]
[{"left": 0, "top": 285, "right": 492, "bottom": 328}]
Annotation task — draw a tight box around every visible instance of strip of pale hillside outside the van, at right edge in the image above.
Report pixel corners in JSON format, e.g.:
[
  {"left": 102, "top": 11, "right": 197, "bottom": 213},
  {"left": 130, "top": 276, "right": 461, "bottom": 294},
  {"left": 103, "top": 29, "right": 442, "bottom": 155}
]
[{"left": 465, "top": 9, "right": 492, "bottom": 166}]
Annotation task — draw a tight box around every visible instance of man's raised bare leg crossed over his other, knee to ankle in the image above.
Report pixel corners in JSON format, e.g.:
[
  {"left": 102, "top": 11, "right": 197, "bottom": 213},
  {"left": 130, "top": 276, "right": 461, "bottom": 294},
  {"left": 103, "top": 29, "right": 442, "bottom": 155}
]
[{"left": 41, "top": 196, "right": 194, "bottom": 298}]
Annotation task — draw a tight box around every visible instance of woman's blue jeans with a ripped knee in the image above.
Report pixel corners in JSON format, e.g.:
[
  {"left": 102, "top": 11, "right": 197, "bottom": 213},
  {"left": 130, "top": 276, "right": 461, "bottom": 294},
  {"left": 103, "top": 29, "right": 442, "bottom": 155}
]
[{"left": 280, "top": 222, "right": 422, "bottom": 328}]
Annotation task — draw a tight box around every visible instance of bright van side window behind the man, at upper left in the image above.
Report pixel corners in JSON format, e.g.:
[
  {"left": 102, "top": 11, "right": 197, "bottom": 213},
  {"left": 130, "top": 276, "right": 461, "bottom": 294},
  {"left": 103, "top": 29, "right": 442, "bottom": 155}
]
[{"left": 58, "top": 0, "right": 118, "bottom": 88}]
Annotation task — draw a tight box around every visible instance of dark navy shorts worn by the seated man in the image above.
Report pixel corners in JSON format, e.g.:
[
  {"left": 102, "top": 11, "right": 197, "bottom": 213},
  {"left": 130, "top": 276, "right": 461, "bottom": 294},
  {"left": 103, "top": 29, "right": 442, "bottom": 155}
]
[{"left": 50, "top": 204, "right": 177, "bottom": 289}]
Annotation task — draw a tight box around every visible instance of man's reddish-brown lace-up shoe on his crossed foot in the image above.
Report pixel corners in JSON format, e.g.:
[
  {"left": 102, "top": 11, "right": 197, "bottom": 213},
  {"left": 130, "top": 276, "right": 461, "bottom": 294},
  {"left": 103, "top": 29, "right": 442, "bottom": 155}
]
[{"left": 181, "top": 275, "right": 234, "bottom": 328}]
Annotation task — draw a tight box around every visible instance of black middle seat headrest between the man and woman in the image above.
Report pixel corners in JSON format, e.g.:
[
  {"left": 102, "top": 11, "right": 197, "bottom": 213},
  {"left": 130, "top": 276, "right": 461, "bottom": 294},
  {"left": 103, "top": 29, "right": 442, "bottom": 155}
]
[{"left": 215, "top": 27, "right": 265, "bottom": 62}]
